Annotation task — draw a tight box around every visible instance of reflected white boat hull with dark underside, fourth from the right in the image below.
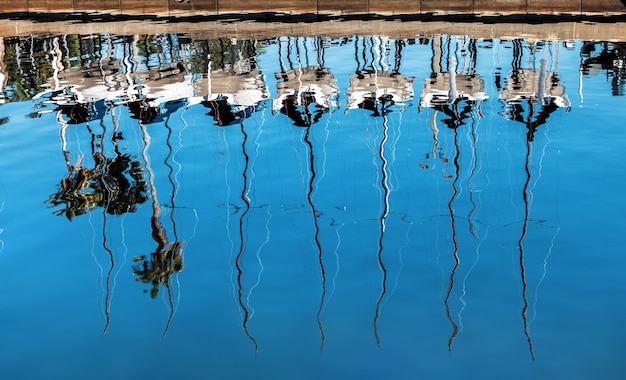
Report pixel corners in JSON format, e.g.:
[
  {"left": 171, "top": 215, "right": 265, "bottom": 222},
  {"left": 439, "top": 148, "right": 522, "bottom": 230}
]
[{"left": 272, "top": 38, "right": 339, "bottom": 127}]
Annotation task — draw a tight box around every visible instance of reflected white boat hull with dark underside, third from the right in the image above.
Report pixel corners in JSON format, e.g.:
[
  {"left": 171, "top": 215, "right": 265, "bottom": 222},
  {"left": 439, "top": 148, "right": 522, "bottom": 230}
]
[{"left": 347, "top": 37, "right": 413, "bottom": 116}]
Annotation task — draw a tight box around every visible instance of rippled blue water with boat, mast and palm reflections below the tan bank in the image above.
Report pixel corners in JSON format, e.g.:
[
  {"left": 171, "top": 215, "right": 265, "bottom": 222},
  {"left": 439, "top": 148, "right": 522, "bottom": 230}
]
[{"left": 0, "top": 35, "right": 626, "bottom": 379}]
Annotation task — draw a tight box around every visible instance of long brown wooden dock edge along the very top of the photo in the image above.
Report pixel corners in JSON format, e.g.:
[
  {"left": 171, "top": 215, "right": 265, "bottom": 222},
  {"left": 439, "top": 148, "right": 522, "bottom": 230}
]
[{"left": 0, "top": 0, "right": 626, "bottom": 17}]
